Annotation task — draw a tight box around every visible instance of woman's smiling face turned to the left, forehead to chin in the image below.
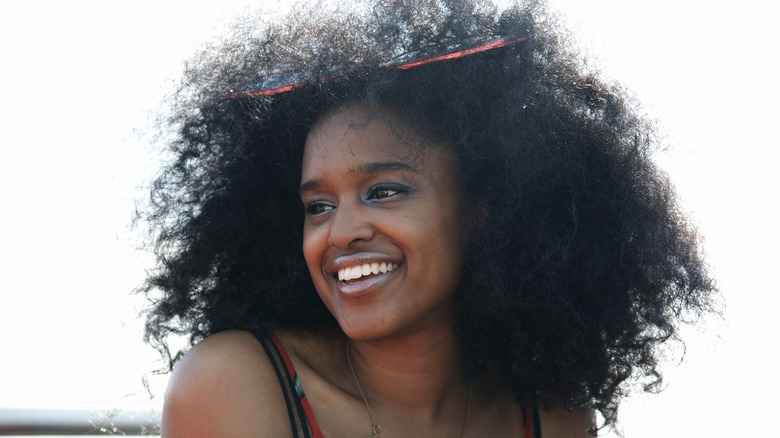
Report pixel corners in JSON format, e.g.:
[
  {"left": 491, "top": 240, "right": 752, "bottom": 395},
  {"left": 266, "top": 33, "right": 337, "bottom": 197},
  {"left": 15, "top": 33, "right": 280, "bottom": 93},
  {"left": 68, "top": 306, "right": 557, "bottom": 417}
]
[{"left": 301, "top": 105, "right": 471, "bottom": 339}]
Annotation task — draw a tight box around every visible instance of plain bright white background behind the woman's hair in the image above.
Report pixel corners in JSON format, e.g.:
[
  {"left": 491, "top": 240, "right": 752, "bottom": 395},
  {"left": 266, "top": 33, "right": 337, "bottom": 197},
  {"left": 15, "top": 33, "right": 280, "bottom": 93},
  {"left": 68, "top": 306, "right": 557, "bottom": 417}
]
[{"left": 0, "top": 0, "right": 780, "bottom": 438}]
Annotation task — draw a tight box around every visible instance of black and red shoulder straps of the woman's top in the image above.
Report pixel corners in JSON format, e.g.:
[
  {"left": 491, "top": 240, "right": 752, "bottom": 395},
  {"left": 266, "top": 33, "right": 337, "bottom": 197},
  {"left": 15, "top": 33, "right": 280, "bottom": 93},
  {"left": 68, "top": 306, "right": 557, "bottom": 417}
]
[{"left": 252, "top": 330, "right": 542, "bottom": 438}]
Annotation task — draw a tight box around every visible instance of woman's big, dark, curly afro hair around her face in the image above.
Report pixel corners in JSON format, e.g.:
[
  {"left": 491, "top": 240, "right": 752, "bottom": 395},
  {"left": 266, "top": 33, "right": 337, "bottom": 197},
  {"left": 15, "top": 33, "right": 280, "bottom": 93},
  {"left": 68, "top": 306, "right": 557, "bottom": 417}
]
[{"left": 142, "top": 0, "right": 716, "bottom": 424}]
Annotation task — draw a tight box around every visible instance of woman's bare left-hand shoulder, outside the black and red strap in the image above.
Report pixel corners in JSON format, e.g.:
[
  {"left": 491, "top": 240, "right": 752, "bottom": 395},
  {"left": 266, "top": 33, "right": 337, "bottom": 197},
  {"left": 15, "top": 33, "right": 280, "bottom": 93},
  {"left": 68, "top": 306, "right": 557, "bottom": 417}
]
[{"left": 162, "top": 330, "right": 292, "bottom": 438}]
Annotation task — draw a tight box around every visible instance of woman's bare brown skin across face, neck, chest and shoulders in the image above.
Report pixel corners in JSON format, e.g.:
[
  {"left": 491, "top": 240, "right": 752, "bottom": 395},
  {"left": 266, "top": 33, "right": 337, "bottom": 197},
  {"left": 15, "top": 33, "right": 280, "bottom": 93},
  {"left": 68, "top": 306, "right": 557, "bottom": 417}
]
[{"left": 163, "top": 105, "right": 592, "bottom": 438}]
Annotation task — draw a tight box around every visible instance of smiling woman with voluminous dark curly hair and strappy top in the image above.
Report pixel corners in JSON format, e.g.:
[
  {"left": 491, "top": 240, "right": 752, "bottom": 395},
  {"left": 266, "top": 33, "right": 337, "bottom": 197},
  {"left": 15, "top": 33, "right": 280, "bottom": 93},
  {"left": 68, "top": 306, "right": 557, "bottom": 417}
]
[{"left": 137, "top": 0, "right": 714, "bottom": 438}]
